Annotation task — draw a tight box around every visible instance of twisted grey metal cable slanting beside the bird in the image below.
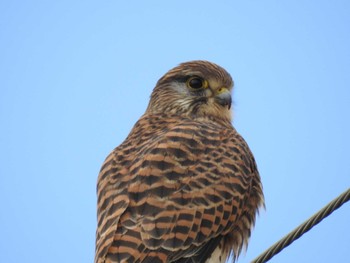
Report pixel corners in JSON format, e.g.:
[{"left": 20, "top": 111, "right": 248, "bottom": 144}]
[{"left": 251, "top": 188, "right": 350, "bottom": 263}]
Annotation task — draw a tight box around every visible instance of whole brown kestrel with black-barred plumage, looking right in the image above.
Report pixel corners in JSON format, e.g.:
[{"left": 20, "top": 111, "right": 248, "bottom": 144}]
[{"left": 95, "top": 60, "right": 264, "bottom": 263}]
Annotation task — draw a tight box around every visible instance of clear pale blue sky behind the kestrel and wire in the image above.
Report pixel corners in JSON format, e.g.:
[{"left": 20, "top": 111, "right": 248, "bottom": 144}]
[{"left": 0, "top": 0, "right": 350, "bottom": 263}]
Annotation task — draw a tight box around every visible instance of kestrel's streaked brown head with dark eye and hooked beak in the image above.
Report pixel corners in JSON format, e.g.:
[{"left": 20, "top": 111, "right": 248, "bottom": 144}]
[{"left": 147, "top": 60, "right": 233, "bottom": 124}]
